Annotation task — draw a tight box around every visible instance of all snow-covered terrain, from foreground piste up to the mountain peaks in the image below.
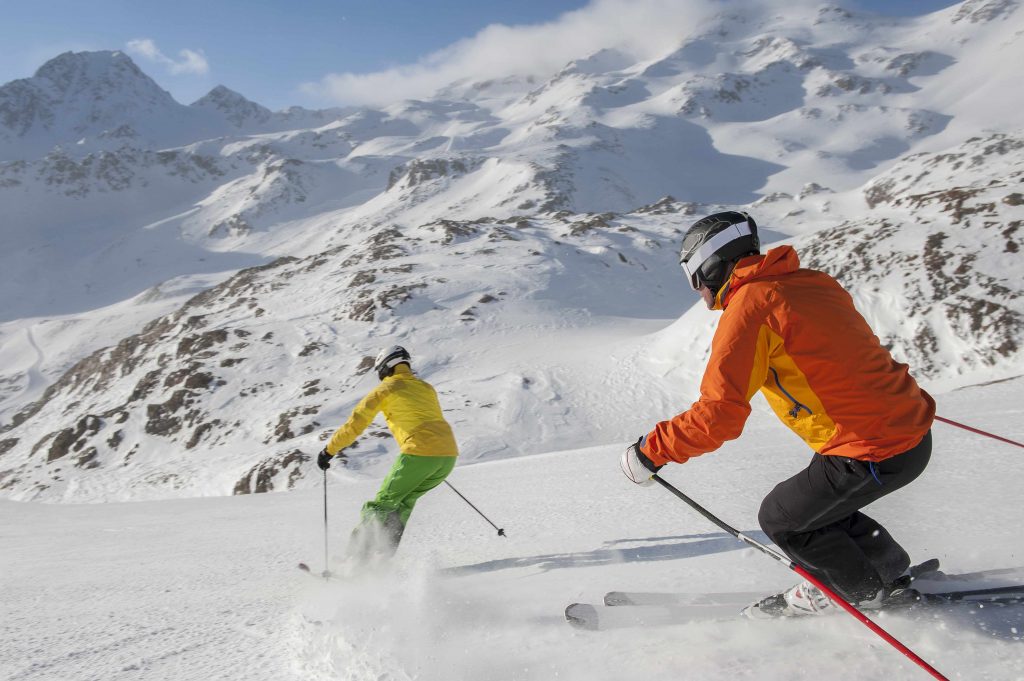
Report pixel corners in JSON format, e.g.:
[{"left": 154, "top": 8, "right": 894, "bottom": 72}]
[{"left": 0, "top": 0, "right": 1024, "bottom": 681}]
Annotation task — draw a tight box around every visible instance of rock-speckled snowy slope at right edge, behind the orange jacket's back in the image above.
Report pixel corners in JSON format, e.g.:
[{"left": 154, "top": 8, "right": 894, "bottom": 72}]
[{"left": 800, "top": 134, "right": 1024, "bottom": 378}]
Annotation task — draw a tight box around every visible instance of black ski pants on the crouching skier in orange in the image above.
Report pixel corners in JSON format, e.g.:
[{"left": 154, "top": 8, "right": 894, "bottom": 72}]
[{"left": 758, "top": 431, "right": 932, "bottom": 602}]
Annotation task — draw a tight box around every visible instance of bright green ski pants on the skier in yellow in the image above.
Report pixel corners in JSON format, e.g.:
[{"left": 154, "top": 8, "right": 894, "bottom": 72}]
[{"left": 360, "top": 454, "right": 457, "bottom": 528}]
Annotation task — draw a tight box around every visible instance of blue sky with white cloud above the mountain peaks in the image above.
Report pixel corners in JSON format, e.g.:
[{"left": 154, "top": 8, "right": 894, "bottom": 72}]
[{"left": 0, "top": 0, "right": 954, "bottom": 110}]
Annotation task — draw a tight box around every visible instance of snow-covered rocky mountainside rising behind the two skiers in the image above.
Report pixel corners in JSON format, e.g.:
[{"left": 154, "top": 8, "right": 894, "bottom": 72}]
[{"left": 0, "top": 0, "right": 1024, "bottom": 501}]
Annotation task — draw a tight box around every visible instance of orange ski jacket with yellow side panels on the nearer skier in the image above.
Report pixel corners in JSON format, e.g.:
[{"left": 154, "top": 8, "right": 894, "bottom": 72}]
[{"left": 643, "top": 246, "right": 935, "bottom": 465}]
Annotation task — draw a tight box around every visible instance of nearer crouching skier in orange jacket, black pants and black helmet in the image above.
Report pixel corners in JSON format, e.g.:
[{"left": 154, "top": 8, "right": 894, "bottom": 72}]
[{"left": 622, "top": 211, "right": 935, "bottom": 616}]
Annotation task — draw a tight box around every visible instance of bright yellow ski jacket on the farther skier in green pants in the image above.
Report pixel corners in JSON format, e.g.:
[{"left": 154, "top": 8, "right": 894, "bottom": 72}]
[{"left": 327, "top": 365, "right": 459, "bottom": 457}]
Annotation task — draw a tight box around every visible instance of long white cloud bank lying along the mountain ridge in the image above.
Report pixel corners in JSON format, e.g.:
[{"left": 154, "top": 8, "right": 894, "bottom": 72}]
[{"left": 300, "top": 0, "right": 794, "bottom": 104}]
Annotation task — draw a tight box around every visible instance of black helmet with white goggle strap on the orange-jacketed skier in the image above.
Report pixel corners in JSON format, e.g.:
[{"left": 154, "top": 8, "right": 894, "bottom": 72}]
[{"left": 679, "top": 211, "right": 761, "bottom": 294}]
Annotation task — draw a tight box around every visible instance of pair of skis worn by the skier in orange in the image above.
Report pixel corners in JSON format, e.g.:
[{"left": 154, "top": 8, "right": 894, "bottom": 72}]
[{"left": 565, "top": 585, "right": 1024, "bottom": 631}]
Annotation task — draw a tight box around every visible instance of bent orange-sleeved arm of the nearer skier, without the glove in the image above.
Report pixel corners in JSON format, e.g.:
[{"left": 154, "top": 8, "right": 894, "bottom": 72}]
[{"left": 643, "top": 294, "right": 769, "bottom": 466}]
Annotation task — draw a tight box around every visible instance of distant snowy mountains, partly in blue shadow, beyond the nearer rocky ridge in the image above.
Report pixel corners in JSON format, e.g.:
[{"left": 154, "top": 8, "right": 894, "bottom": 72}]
[{"left": 0, "top": 0, "right": 1022, "bottom": 405}]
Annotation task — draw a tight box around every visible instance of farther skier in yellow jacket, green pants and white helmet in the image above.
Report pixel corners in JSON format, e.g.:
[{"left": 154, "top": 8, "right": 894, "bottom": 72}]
[{"left": 316, "top": 345, "right": 459, "bottom": 561}]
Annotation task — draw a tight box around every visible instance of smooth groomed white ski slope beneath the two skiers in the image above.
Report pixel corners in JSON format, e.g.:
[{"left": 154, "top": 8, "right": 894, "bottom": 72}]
[{"left": 0, "top": 378, "right": 1024, "bottom": 681}]
